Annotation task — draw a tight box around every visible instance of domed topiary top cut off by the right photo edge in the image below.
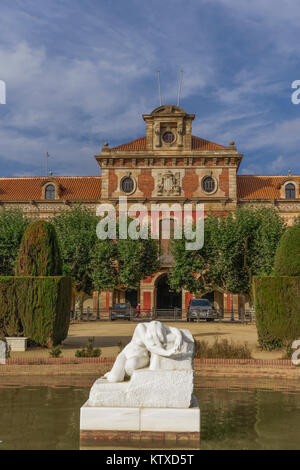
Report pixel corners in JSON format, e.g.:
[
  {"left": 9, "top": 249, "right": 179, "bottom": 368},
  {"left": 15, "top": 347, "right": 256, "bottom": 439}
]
[{"left": 274, "top": 225, "right": 300, "bottom": 276}]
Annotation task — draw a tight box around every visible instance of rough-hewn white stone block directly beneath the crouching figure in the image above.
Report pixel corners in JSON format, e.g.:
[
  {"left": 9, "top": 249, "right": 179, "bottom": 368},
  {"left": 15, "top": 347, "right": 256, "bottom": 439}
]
[{"left": 88, "top": 369, "right": 193, "bottom": 409}]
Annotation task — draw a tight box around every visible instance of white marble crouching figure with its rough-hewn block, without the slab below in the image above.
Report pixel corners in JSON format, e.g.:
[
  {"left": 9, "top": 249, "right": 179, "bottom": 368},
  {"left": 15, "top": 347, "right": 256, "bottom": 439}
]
[{"left": 88, "top": 321, "right": 194, "bottom": 408}]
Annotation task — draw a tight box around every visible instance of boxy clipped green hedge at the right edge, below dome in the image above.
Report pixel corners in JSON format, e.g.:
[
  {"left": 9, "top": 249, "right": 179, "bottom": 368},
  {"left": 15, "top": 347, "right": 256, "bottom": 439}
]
[{"left": 253, "top": 276, "right": 300, "bottom": 349}]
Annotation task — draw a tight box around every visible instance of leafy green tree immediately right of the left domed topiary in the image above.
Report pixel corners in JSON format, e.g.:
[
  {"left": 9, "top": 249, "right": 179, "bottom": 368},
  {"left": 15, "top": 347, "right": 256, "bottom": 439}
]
[{"left": 51, "top": 205, "right": 99, "bottom": 310}]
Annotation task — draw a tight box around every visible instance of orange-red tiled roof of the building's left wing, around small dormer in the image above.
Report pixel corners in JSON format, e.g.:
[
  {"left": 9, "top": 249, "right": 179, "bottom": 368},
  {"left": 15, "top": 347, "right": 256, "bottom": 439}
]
[{"left": 0, "top": 176, "right": 101, "bottom": 200}]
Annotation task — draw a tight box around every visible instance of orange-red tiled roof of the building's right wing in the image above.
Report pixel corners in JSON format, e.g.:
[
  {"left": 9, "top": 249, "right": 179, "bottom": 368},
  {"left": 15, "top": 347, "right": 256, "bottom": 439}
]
[{"left": 237, "top": 175, "right": 300, "bottom": 199}]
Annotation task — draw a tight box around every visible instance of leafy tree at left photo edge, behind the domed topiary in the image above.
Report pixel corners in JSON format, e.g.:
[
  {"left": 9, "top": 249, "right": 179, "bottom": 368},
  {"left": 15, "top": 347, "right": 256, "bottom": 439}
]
[{"left": 0, "top": 209, "right": 30, "bottom": 276}]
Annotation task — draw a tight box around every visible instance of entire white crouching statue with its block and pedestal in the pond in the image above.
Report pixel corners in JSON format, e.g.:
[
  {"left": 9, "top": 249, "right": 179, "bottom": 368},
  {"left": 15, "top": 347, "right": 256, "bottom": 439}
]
[{"left": 80, "top": 321, "right": 200, "bottom": 449}]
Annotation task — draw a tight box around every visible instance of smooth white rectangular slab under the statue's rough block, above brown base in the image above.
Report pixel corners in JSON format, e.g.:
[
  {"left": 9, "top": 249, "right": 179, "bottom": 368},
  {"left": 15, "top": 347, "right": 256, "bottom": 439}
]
[{"left": 80, "top": 397, "right": 200, "bottom": 433}]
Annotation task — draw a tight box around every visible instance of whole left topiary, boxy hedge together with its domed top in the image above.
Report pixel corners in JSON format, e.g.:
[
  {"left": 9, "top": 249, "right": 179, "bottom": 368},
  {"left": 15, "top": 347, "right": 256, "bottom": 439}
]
[{"left": 0, "top": 220, "right": 72, "bottom": 346}]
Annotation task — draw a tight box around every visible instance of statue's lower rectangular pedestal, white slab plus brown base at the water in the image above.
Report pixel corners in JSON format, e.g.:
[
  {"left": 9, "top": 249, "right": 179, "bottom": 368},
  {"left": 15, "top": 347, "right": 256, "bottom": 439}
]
[{"left": 80, "top": 396, "right": 200, "bottom": 448}]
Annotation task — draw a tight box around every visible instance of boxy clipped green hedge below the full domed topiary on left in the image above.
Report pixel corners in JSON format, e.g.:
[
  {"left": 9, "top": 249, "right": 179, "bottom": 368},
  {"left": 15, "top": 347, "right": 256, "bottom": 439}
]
[{"left": 0, "top": 276, "right": 72, "bottom": 347}]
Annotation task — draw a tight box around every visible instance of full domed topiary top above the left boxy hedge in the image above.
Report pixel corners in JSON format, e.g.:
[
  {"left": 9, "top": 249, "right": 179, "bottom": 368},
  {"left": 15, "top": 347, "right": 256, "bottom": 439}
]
[{"left": 16, "top": 220, "right": 62, "bottom": 276}]
